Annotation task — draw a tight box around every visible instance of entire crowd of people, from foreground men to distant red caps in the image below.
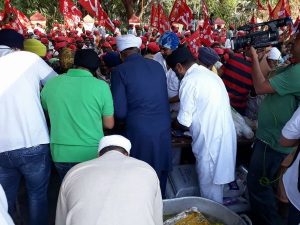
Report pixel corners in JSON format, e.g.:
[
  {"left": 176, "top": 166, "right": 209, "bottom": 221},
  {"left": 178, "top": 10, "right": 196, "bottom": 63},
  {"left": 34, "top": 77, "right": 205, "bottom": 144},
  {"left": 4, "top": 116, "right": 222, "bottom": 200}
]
[{"left": 0, "top": 16, "right": 300, "bottom": 225}]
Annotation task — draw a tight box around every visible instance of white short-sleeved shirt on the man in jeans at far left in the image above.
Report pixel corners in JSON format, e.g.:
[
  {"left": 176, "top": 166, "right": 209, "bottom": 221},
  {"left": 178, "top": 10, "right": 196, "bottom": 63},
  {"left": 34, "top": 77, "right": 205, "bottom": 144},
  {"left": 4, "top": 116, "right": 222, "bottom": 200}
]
[{"left": 0, "top": 51, "right": 56, "bottom": 152}]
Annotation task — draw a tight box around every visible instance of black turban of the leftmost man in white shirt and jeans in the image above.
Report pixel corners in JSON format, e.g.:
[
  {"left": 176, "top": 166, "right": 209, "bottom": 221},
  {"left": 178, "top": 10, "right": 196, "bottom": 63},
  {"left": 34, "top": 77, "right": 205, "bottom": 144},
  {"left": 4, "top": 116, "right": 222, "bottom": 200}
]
[{"left": 0, "top": 29, "right": 24, "bottom": 49}]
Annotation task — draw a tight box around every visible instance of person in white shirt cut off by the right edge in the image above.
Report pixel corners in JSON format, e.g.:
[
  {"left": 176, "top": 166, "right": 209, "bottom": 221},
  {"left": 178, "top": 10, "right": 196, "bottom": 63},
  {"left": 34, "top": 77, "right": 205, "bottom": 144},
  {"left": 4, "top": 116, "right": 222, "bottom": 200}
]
[{"left": 280, "top": 107, "right": 300, "bottom": 225}]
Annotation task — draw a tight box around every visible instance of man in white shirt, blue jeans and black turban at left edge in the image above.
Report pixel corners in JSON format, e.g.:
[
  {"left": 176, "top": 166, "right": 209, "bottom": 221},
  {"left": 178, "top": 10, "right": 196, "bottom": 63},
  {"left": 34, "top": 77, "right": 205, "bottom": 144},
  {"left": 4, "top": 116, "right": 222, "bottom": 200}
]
[{"left": 0, "top": 29, "right": 56, "bottom": 225}]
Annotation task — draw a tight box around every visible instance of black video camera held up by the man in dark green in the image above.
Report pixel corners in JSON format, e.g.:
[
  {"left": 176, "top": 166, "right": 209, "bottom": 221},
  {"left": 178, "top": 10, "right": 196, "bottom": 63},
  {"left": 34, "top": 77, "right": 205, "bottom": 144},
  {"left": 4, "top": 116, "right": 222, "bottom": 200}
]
[{"left": 230, "top": 17, "right": 293, "bottom": 50}]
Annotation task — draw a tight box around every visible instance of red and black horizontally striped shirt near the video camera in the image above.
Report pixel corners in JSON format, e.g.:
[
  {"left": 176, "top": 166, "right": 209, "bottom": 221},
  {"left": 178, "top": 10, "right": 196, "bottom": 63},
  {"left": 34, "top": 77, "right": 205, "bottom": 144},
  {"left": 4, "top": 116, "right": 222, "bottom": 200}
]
[{"left": 221, "top": 54, "right": 253, "bottom": 115}]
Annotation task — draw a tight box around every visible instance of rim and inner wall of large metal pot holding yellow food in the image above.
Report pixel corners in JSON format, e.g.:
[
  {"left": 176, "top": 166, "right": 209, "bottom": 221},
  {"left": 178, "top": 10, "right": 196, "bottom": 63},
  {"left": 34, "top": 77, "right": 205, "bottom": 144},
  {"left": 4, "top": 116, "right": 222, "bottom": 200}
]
[{"left": 163, "top": 197, "right": 247, "bottom": 225}]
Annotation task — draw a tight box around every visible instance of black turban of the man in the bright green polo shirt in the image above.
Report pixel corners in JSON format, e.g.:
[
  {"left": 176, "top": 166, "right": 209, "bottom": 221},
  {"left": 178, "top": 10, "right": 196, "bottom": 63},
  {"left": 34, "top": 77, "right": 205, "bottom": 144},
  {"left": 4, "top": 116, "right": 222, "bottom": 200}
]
[{"left": 74, "top": 49, "right": 99, "bottom": 72}]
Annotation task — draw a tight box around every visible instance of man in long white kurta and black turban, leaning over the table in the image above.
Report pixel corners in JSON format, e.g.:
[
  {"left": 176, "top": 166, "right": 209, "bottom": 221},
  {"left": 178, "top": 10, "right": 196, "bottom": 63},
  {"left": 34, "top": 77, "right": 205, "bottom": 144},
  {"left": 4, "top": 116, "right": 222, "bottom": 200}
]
[{"left": 167, "top": 47, "right": 236, "bottom": 203}]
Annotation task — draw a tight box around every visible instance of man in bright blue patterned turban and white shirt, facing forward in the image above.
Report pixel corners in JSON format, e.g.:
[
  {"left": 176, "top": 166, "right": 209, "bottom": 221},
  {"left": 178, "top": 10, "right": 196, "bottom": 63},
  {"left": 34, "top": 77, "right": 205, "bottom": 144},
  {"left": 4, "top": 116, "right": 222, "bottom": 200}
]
[{"left": 153, "top": 31, "right": 180, "bottom": 112}]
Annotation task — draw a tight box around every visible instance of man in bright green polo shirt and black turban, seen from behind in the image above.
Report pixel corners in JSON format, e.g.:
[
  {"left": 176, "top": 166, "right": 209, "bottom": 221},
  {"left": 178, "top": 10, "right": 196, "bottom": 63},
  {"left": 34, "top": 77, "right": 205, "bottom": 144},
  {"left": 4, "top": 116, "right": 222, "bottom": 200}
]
[{"left": 41, "top": 49, "right": 114, "bottom": 179}]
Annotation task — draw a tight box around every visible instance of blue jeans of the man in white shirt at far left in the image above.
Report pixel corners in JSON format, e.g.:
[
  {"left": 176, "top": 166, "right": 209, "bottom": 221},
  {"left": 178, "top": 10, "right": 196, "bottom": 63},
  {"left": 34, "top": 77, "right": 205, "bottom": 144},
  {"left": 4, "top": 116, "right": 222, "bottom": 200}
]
[{"left": 0, "top": 145, "right": 51, "bottom": 225}]
